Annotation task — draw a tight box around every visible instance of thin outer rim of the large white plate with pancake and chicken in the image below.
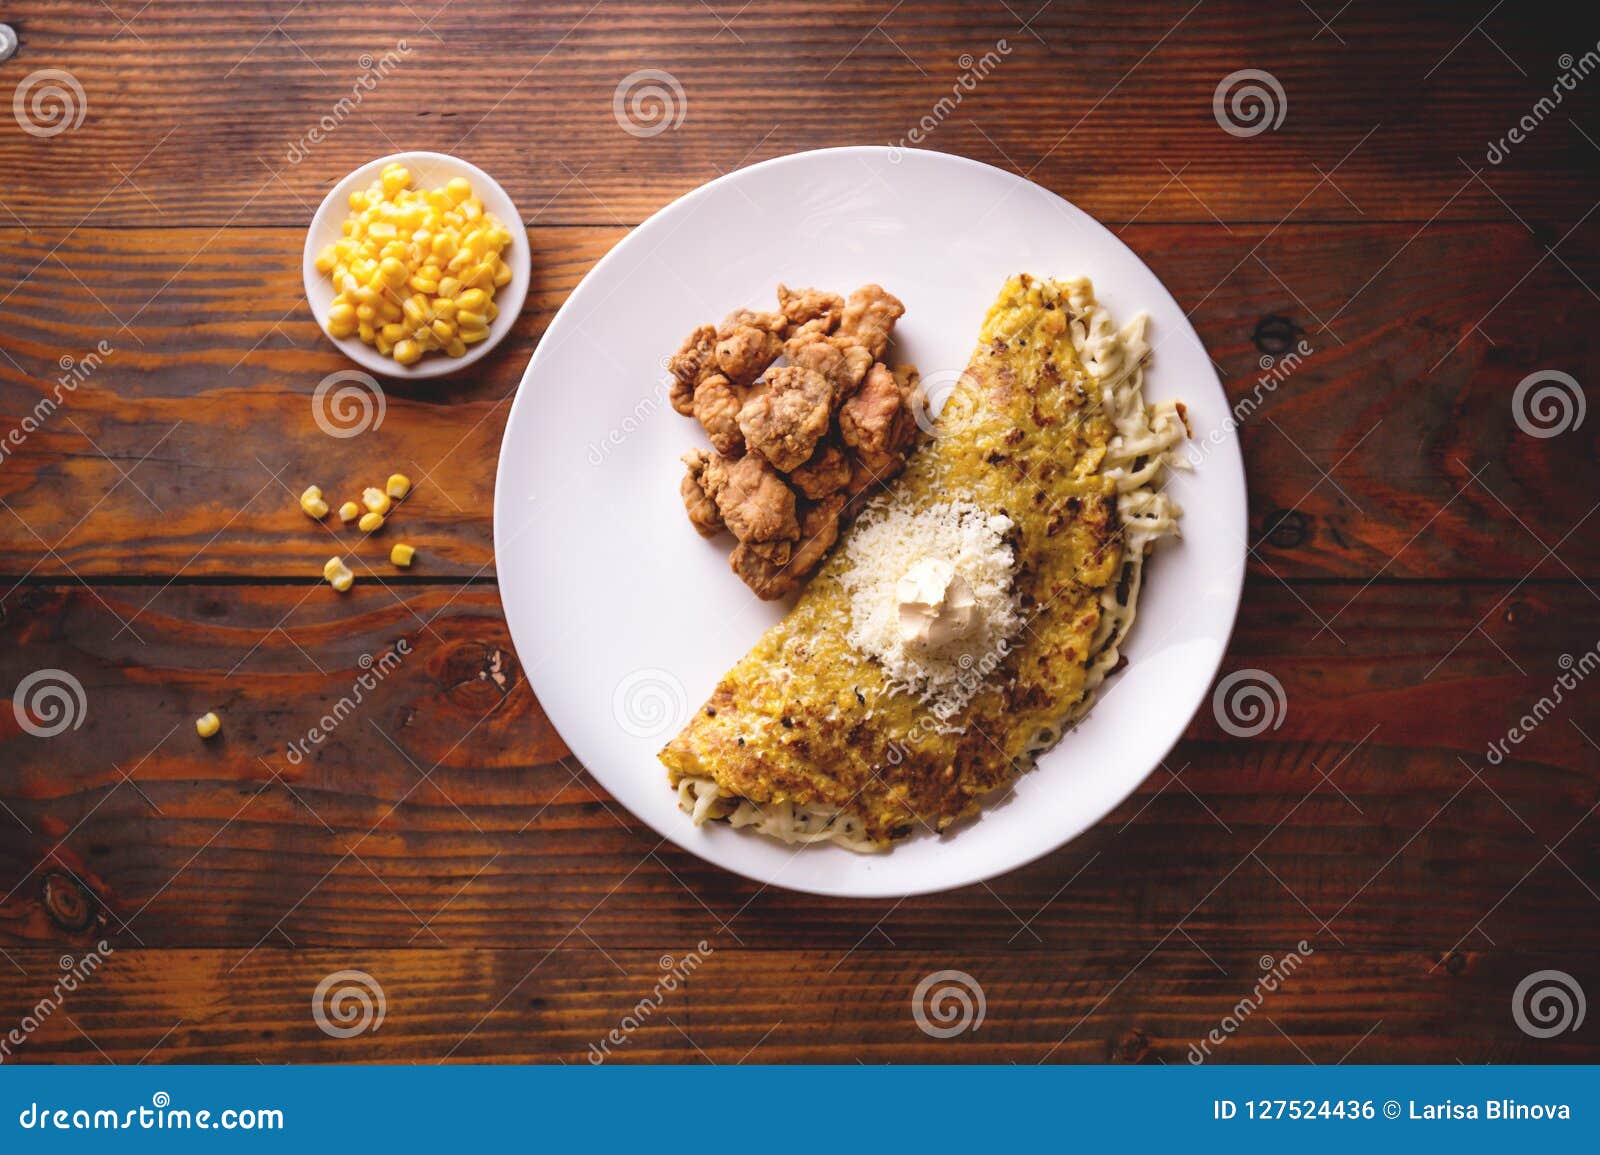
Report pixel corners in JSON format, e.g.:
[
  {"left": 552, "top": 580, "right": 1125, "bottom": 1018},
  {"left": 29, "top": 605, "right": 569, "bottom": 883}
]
[{"left": 493, "top": 144, "right": 1250, "bottom": 901}]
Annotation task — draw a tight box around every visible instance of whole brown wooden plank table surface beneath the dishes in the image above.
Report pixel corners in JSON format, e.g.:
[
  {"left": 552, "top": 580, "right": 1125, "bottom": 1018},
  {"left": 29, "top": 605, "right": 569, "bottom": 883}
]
[{"left": 0, "top": 0, "right": 1600, "bottom": 1064}]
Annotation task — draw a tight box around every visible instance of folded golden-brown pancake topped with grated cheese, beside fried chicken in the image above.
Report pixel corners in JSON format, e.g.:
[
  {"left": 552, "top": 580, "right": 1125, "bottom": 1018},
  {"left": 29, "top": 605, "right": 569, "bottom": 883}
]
[{"left": 661, "top": 275, "right": 1186, "bottom": 849}]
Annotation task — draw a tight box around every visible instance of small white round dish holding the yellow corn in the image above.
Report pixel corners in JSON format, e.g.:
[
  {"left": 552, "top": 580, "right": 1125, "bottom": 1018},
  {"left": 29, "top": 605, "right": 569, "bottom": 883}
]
[{"left": 301, "top": 152, "right": 530, "bottom": 381}]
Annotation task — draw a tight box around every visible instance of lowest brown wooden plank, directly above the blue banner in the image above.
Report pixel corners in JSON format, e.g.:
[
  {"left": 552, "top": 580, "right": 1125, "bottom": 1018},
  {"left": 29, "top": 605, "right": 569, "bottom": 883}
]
[{"left": 0, "top": 941, "right": 1600, "bottom": 1065}]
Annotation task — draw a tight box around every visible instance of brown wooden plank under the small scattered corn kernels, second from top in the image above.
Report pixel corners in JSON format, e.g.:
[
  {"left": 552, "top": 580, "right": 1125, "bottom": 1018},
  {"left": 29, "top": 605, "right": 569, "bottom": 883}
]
[{"left": 0, "top": 222, "right": 1600, "bottom": 579}]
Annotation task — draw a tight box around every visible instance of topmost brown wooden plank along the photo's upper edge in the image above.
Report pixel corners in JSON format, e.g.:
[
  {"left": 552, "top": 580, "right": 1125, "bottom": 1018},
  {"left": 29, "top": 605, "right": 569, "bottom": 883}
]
[{"left": 0, "top": 0, "right": 1600, "bottom": 229}]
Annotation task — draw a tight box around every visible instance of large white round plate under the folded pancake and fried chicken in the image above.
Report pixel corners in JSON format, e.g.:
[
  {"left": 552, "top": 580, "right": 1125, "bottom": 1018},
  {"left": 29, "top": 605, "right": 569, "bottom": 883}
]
[{"left": 494, "top": 147, "right": 1246, "bottom": 897}]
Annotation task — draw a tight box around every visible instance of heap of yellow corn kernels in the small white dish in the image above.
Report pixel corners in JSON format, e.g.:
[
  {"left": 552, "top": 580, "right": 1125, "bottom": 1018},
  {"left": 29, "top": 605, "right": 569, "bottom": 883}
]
[{"left": 315, "top": 165, "right": 512, "bottom": 365}]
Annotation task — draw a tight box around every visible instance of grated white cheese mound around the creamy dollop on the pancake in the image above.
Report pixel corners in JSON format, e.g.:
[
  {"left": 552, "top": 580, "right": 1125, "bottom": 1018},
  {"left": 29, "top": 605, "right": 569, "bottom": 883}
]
[{"left": 840, "top": 496, "right": 1022, "bottom": 728}]
